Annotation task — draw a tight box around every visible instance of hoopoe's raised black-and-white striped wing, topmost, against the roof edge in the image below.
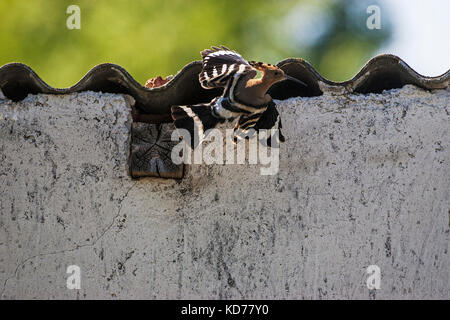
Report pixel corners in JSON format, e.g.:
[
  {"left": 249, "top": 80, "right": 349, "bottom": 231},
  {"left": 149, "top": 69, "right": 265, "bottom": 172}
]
[{"left": 199, "top": 46, "right": 257, "bottom": 89}]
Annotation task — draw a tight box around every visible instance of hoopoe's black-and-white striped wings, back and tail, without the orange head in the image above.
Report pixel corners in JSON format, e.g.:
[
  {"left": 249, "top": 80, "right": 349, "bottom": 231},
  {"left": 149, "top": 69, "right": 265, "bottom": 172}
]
[{"left": 172, "top": 46, "right": 284, "bottom": 148}]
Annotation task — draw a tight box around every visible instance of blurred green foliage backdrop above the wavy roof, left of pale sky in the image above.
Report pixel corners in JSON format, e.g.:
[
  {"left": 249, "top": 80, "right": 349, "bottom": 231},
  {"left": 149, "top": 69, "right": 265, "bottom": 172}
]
[{"left": 0, "top": 0, "right": 390, "bottom": 87}]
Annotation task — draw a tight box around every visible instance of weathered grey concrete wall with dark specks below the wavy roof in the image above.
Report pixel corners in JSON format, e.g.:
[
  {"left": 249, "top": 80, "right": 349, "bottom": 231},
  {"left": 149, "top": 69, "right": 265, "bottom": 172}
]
[{"left": 0, "top": 86, "right": 450, "bottom": 299}]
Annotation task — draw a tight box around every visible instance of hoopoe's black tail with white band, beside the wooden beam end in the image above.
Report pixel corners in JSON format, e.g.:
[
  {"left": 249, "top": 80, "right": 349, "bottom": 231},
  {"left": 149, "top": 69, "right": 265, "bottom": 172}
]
[{"left": 171, "top": 104, "right": 224, "bottom": 149}]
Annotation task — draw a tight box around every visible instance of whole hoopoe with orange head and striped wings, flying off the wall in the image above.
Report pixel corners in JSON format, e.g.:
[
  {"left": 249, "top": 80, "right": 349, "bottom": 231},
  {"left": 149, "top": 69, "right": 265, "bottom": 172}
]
[{"left": 171, "top": 46, "right": 306, "bottom": 149}]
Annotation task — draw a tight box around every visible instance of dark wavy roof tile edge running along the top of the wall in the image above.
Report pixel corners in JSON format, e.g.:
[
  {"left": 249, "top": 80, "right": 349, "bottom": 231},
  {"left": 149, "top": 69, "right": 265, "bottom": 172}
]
[{"left": 0, "top": 54, "right": 450, "bottom": 115}]
